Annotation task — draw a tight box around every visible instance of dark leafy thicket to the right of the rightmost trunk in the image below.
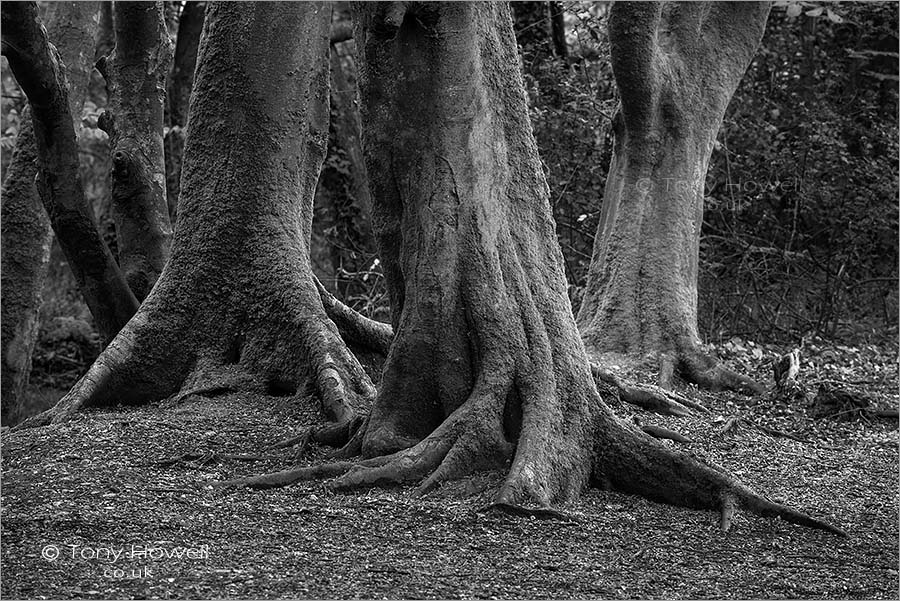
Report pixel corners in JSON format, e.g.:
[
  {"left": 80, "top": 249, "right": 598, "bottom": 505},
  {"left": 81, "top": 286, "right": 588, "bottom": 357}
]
[{"left": 700, "top": 3, "right": 898, "bottom": 340}]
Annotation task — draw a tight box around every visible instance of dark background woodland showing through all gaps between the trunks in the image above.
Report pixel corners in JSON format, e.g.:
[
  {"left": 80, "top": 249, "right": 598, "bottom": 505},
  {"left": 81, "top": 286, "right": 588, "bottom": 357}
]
[{"left": 0, "top": 2, "right": 898, "bottom": 422}]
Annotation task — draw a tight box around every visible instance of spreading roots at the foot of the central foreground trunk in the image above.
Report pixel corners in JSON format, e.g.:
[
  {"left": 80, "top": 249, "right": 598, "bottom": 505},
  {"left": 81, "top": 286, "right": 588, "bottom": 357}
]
[{"left": 216, "top": 380, "right": 846, "bottom": 536}]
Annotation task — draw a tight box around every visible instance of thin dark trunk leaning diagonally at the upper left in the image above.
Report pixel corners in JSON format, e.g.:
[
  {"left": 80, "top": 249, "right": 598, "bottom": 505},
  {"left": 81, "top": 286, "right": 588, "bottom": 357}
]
[{"left": 2, "top": 2, "right": 137, "bottom": 341}]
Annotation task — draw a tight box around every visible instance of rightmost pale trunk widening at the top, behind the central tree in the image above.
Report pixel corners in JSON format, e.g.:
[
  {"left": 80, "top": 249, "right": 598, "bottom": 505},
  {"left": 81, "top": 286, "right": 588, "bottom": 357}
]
[{"left": 578, "top": 2, "right": 769, "bottom": 392}]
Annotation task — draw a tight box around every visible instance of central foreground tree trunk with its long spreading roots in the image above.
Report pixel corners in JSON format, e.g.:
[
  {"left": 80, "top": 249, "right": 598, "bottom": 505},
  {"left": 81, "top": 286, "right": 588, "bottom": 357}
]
[{"left": 225, "top": 2, "right": 835, "bottom": 531}]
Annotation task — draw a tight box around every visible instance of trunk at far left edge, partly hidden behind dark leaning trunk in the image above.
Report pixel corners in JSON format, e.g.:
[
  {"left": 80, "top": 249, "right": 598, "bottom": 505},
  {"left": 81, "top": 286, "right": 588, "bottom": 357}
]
[{"left": 0, "top": 2, "right": 98, "bottom": 425}]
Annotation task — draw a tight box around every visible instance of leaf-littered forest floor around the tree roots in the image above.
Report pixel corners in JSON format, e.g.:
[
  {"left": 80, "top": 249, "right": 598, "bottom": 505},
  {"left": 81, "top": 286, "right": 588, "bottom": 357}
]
[{"left": 0, "top": 341, "right": 898, "bottom": 599}]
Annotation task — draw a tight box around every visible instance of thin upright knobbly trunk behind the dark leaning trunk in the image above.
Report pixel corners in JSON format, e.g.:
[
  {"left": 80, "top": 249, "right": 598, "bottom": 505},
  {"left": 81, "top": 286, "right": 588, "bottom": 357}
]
[{"left": 98, "top": 2, "right": 172, "bottom": 300}]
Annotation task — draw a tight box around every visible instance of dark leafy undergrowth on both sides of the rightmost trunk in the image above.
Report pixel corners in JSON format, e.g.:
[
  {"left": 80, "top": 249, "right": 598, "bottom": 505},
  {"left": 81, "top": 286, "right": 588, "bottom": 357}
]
[{"left": 519, "top": 2, "right": 898, "bottom": 342}]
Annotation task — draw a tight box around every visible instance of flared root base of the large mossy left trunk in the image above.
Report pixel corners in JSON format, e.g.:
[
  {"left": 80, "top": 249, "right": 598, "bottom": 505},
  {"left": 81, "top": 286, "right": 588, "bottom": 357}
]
[{"left": 18, "top": 280, "right": 375, "bottom": 428}]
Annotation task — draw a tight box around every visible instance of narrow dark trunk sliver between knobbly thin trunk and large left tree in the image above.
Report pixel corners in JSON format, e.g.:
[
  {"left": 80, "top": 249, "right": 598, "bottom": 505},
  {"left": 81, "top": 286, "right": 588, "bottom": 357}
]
[{"left": 165, "top": 1, "right": 206, "bottom": 224}]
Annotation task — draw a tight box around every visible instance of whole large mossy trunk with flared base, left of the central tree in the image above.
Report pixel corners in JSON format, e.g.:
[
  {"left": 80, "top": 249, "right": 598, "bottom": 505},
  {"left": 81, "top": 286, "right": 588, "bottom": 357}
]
[{"left": 20, "top": 2, "right": 374, "bottom": 432}]
